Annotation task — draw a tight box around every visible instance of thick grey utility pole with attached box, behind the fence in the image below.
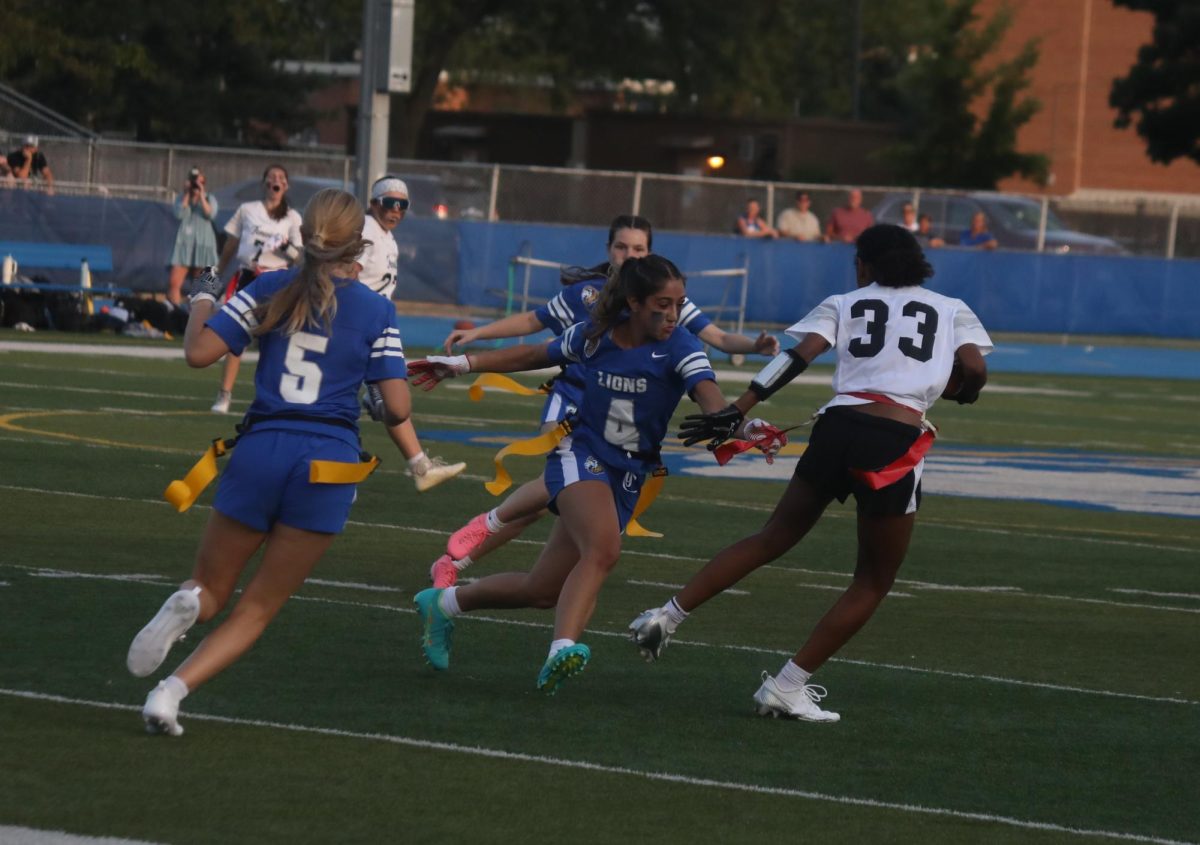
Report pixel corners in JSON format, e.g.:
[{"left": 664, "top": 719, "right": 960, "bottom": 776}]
[{"left": 354, "top": 0, "right": 416, "bottom": 203}]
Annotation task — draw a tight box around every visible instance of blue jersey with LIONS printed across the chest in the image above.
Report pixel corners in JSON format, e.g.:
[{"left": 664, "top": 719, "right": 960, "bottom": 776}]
[{"left": 547, "top": 323, "right": 716, "bottom": 473}]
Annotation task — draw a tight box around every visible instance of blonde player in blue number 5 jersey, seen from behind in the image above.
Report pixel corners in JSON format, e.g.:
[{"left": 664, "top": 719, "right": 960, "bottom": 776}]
[{"left": 126, "top": 190, "right": 410, "bottom": 736}]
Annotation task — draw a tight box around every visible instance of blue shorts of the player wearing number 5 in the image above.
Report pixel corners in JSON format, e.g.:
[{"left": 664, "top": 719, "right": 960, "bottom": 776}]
[{"left": 212, "top": 430, "right": 359, "bottom": 534}]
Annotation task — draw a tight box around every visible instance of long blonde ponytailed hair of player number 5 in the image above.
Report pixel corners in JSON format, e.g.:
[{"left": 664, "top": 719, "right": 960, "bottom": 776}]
[{"left": 253, "top": 188, "right": 368, "bottom": 335}]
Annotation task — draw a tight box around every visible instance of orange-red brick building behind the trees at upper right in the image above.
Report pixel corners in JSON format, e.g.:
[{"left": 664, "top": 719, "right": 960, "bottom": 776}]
[{"left": 978, "top": 0, "right": 1200, "bottom": 194}]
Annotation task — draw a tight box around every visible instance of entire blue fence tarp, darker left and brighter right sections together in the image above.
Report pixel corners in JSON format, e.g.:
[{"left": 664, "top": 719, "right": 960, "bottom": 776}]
[{"left": 0, "top": 196, "right": 1200, "bottom": 337}]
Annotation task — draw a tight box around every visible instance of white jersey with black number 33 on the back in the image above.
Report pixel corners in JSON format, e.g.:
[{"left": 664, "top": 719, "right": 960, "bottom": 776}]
[{"left": 787, "top": 284, "right": 992, "bottom": 413}]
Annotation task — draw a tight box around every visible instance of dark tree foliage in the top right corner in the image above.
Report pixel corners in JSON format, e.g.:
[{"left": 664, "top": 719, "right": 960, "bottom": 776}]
[{"left": 1109, "top": 0, "right": 1200, "bottom": 164}]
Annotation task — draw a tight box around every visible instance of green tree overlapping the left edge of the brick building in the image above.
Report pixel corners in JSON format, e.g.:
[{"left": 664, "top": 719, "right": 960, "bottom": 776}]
[{"left": 886, "top": 0, "right": 1049, "bottom": 188}]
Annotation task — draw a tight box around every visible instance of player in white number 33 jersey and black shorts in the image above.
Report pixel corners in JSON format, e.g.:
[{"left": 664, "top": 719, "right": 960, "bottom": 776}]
[{"left": 630, "top": 224, "right": 992, "bottom": 721}]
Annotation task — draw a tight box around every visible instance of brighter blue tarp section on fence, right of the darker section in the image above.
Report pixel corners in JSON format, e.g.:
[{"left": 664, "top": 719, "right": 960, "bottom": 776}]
[{"left": 458, "top": 222, "right": 1200, "bottom": 337}]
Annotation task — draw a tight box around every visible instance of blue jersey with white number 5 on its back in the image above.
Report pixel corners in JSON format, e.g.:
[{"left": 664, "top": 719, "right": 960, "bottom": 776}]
[{"left": 206, "top": 270, "right": 408, "bottom": 443}]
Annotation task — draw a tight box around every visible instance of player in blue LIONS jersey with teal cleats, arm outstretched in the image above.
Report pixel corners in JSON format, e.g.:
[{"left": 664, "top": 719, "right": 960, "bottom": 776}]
[{"left": 412, "top": 256, "right": 777, "bottom": 694}]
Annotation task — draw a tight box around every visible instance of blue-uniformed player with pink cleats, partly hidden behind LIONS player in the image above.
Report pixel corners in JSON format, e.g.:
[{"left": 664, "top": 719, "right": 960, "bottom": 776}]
[{"left": 430, "top": 215, "right": 779, "bottom": 587}]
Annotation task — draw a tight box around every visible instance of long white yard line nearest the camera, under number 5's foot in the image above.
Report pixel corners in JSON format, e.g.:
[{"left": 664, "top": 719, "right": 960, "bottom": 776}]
[{"left": 0, "top": 688, "right": 1195, "bottom": 845}]
